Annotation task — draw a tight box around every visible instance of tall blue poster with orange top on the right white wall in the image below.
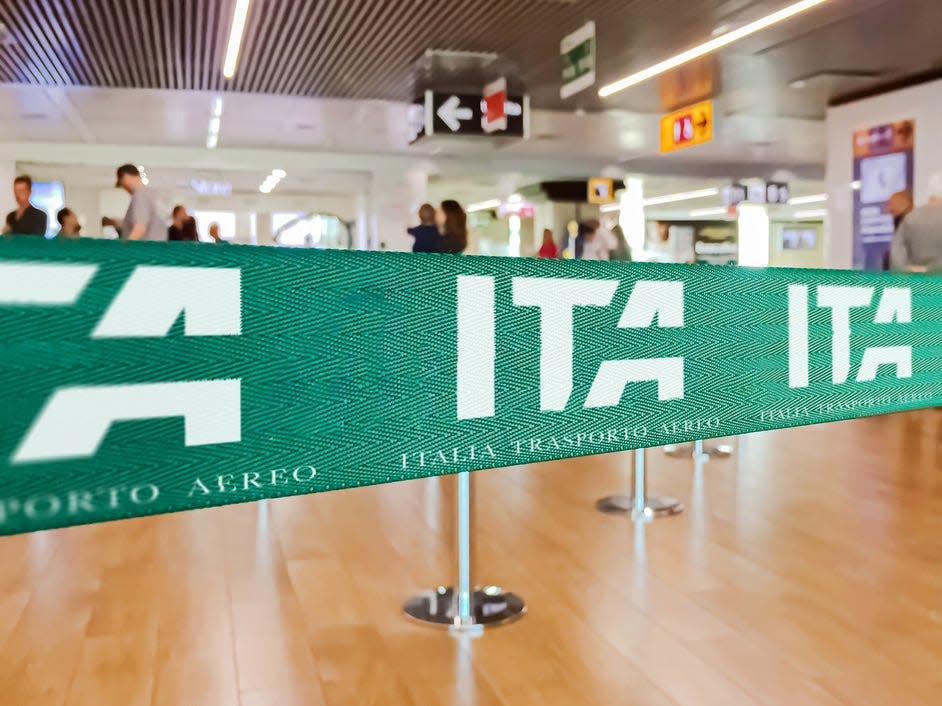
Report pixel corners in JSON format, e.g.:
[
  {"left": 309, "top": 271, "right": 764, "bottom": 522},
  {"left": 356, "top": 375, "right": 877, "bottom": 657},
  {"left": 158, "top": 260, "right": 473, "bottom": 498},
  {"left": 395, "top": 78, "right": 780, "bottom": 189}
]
[{"left": 853, "top": 120, "right": 916, "bottom": 270}]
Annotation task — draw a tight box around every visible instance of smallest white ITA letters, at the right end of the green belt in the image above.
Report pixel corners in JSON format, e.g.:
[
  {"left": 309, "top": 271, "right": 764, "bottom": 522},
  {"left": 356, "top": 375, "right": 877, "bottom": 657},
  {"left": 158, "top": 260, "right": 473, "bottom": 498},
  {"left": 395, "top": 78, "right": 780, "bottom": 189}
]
[{"left": 788, "top": 284, "right": 913, "bottom": 387}]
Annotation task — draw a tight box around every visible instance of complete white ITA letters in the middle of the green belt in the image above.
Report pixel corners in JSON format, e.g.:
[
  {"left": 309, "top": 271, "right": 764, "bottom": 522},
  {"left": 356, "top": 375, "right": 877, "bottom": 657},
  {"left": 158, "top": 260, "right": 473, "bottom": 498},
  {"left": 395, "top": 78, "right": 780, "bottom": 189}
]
[{"left": 457, "top": 276, "right": 684, "bottom": 419}]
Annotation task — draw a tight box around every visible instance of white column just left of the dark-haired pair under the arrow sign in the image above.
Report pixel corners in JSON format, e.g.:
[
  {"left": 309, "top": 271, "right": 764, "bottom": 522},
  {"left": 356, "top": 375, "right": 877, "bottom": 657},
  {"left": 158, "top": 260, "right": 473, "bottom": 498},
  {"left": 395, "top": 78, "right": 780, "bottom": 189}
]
[{"left": 369, "top": 171, "right": 428, "bottom": 252}]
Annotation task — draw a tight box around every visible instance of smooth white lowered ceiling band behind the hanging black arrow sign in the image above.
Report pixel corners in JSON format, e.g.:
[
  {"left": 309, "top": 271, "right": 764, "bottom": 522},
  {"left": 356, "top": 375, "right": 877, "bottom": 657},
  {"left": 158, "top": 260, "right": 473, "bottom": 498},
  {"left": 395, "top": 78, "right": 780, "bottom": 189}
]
[{"left": 0, "top": 84, "right": 825, "bottom": 182}]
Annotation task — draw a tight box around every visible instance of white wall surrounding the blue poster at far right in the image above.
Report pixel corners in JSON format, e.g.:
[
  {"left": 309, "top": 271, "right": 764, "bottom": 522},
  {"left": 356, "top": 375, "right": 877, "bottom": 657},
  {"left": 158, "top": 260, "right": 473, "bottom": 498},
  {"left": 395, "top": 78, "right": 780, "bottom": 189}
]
[{"left": 827, "top": 80, "right": 942, "bottom": 268}]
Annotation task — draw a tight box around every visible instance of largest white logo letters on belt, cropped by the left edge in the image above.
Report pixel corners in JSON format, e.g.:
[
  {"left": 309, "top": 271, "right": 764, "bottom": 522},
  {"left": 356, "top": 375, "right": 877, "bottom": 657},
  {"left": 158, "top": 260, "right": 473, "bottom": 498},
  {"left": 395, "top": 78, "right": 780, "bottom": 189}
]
[{"left": 0, "top": 263, "right": 242, "bottom": 463}]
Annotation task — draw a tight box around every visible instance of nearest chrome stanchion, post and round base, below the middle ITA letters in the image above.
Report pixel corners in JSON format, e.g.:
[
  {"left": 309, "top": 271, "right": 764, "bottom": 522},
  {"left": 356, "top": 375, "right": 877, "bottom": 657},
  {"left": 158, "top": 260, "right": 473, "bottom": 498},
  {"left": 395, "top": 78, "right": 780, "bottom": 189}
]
[{"left": 403, "top": 472, "right": 526, "bottom": 635}]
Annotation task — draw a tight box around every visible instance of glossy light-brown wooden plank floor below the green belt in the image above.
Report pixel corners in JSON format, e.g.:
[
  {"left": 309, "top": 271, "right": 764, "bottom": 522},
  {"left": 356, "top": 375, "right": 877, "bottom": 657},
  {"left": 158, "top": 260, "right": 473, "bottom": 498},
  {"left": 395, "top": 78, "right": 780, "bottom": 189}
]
[{"left": 0, "top": 410, "right": 942, "bottom": 706}]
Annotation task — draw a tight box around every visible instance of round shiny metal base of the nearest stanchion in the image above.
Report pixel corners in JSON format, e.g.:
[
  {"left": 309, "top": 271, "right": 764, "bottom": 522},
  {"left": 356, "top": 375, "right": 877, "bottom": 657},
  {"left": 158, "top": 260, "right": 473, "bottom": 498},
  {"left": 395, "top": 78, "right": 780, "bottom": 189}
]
[{"left": 402, "top": 586, "right": 527, "bottom": 634}]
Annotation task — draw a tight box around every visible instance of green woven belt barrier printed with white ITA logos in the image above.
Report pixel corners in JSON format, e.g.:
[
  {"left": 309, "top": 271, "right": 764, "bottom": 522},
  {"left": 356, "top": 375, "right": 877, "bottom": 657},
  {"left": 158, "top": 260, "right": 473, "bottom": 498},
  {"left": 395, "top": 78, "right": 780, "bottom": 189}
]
[{"left": 0, "top": 238, "right": 942, "bottom": 534}]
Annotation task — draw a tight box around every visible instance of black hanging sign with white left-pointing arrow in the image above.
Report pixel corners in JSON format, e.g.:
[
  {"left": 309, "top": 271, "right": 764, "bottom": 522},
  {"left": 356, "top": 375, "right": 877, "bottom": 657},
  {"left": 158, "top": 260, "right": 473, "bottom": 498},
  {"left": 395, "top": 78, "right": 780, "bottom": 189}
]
[{"left": 409, "top": 91, "right": 530, "bottom": 142}]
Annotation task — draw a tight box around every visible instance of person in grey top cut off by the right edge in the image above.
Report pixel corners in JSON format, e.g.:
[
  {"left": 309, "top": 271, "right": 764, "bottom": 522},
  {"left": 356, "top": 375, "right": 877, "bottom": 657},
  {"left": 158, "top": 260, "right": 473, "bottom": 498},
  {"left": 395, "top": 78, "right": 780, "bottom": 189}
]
[{"left": 890, "top": 173, "right": 942, "bottom": 272}]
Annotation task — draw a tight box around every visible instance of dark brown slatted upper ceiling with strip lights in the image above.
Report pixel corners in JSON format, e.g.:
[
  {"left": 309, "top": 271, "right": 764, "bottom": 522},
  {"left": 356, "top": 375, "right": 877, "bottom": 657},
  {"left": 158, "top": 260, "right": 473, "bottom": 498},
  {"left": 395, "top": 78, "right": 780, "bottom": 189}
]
[{"left": 0, "top": 0, "right": 942, "bottom": 118}]
